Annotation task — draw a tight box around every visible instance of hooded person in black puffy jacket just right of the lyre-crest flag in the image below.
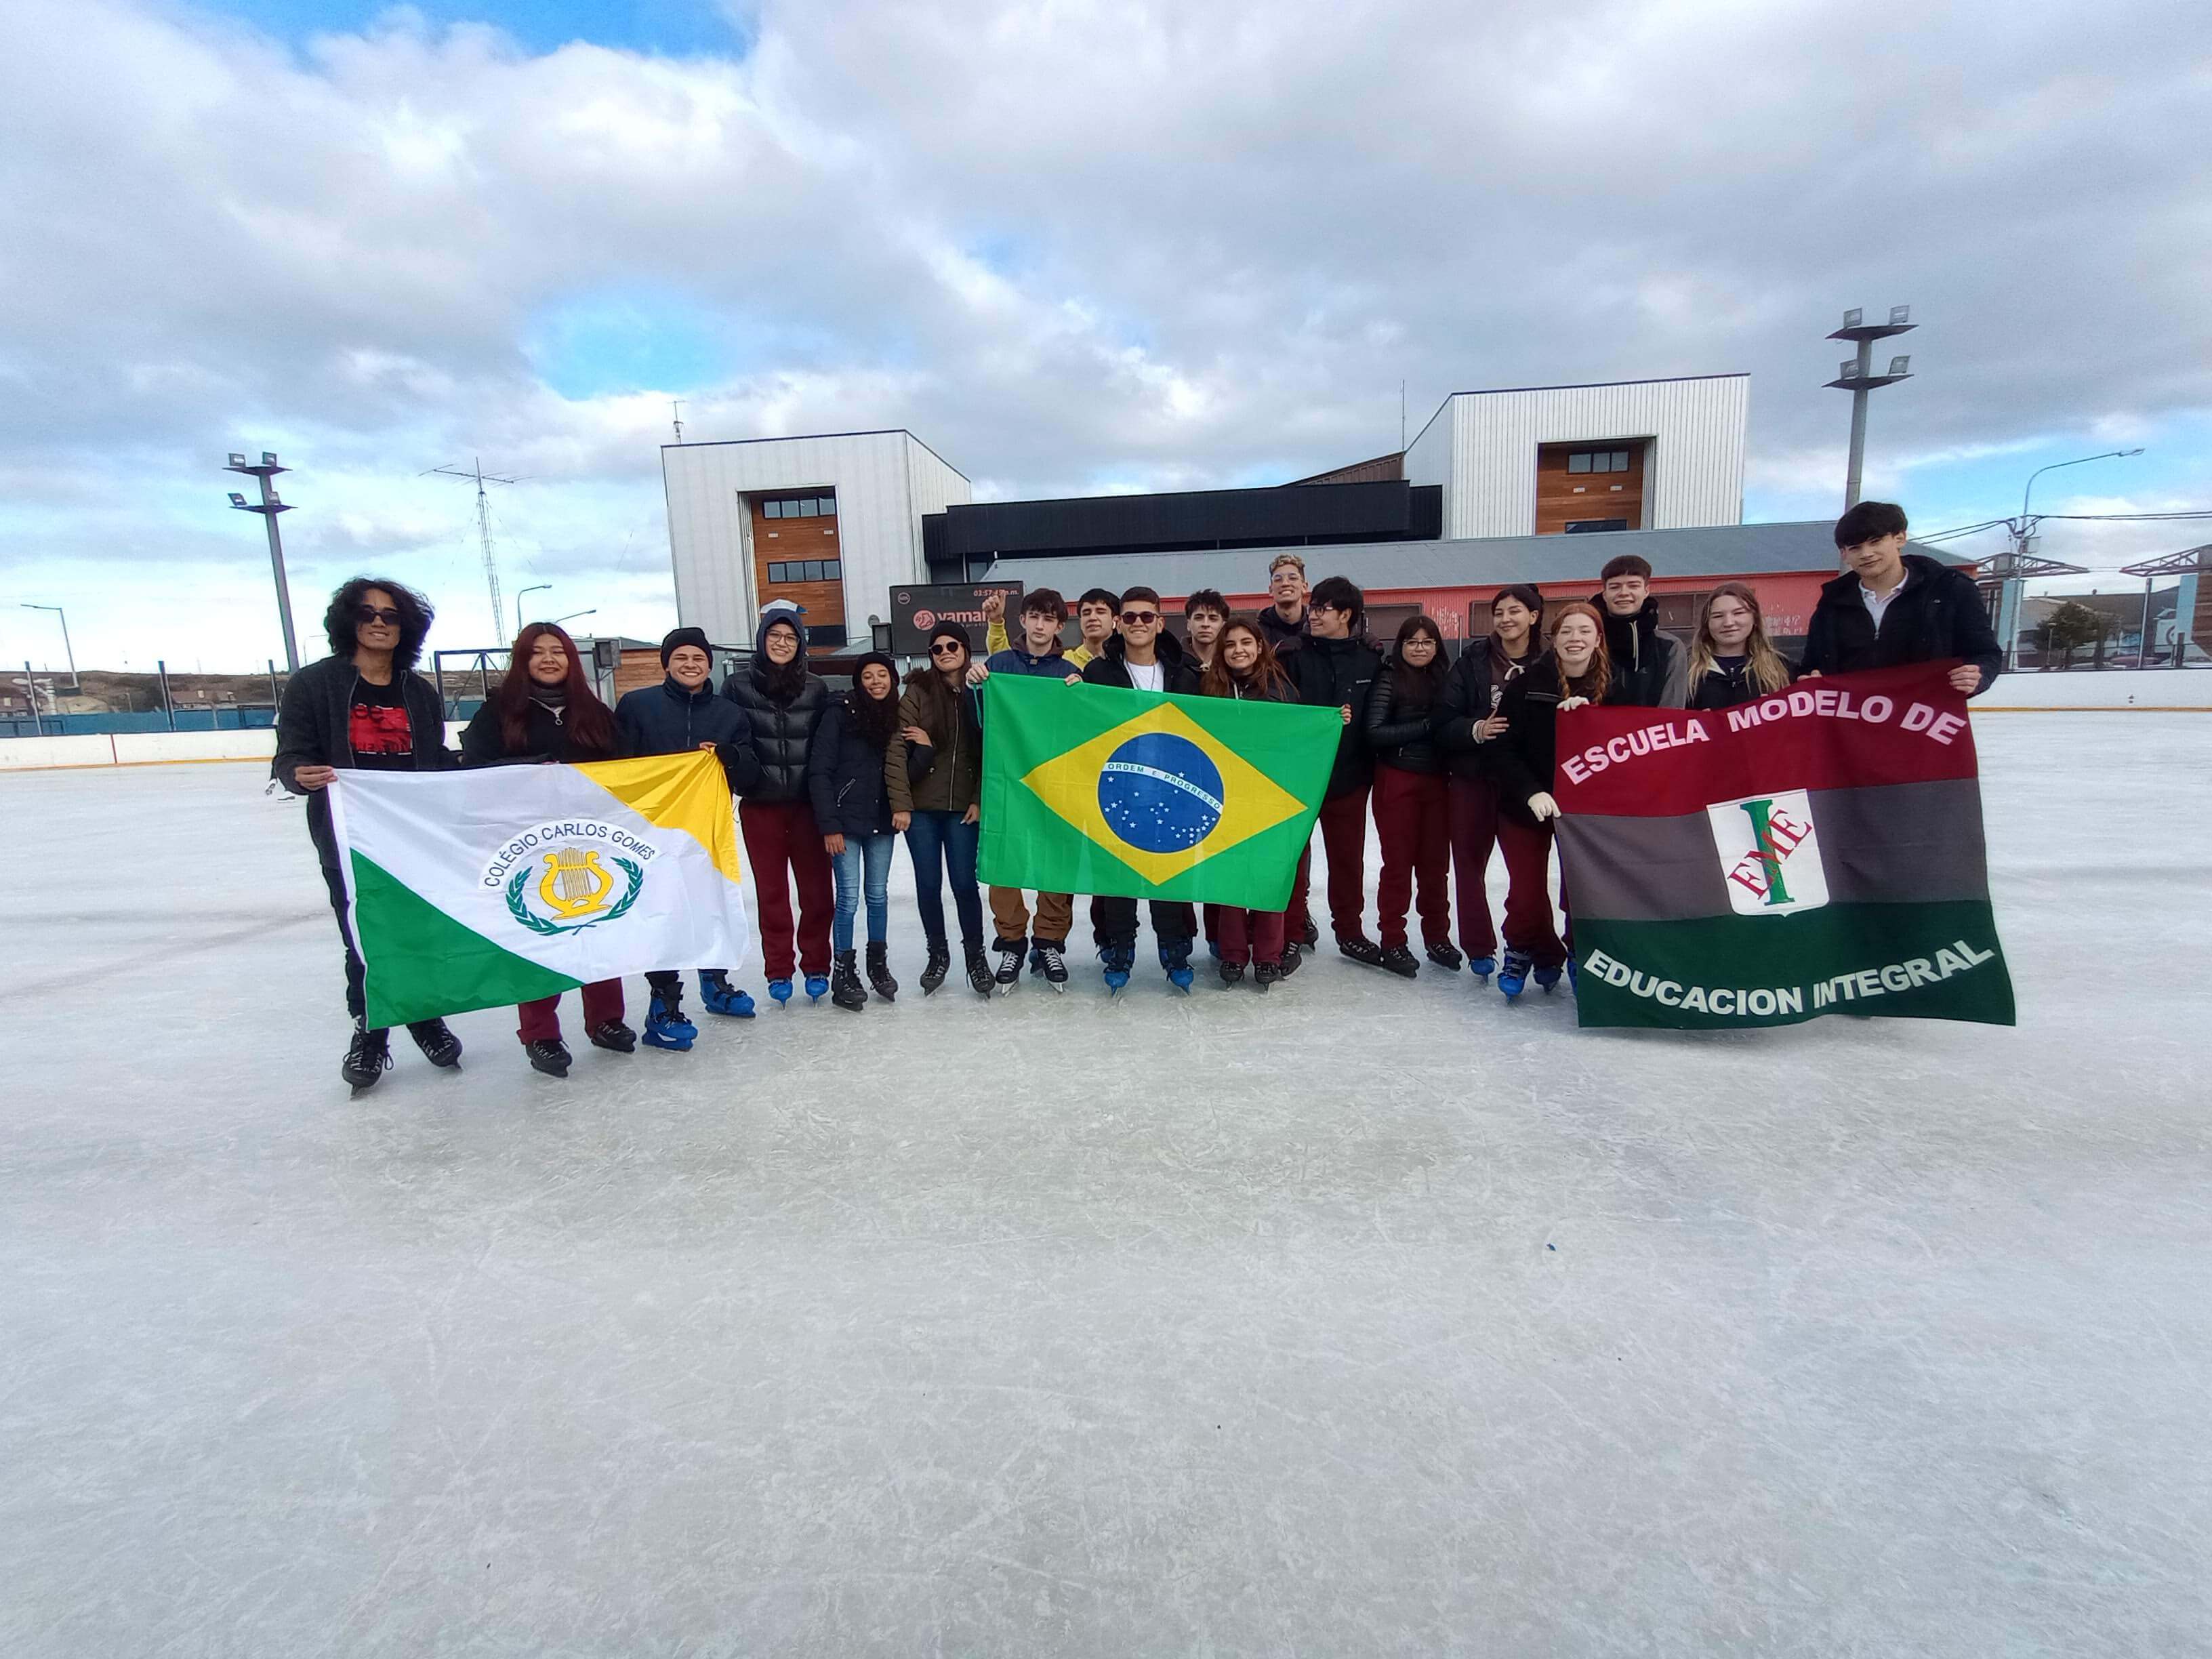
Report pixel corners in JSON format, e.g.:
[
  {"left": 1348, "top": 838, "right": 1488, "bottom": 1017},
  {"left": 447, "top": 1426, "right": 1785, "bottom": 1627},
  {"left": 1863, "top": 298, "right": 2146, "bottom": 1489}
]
[{"left": 721, "top": 609, "right": 836, "bottom": 1004}]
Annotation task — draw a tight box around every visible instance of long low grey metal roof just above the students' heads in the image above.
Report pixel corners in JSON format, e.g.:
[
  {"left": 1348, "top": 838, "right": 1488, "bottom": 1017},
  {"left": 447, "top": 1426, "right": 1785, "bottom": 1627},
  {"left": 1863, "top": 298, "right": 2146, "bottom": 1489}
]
[{"left": 984, "top": 518, "right": 1973, "bottom": 595}]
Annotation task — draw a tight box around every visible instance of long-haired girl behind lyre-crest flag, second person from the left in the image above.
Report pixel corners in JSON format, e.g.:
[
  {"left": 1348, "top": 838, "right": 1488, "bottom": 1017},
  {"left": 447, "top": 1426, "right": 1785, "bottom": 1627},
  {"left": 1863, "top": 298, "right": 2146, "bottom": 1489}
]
[{"left": 460, "top": 621, "right": 637, "bottom": 1078}]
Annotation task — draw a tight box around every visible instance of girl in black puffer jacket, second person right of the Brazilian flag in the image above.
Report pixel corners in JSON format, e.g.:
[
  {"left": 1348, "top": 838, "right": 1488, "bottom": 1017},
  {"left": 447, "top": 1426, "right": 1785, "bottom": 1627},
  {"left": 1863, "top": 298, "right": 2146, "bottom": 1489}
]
[{"left": 1367, "top": 617, "right": 1460, "bottom": 980}]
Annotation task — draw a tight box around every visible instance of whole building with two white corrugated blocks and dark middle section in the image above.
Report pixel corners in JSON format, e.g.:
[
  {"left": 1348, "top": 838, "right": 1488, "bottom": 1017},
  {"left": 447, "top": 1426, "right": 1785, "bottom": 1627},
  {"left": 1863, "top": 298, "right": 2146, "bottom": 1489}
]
[{"left": 661, "top": 374, "right": 1750, "bottom": 648}]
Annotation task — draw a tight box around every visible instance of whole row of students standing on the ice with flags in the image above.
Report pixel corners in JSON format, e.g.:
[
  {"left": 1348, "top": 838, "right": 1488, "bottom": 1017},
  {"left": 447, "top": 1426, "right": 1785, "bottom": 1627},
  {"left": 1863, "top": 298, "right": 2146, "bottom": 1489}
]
[{"left": 274, "top": 502, "right": 2002, "bottom": 1088}]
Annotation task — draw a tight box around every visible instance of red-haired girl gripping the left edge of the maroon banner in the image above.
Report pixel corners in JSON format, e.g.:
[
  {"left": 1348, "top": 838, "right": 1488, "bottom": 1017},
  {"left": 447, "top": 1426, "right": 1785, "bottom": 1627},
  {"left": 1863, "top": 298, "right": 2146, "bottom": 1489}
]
[{"left": 1489, "top": 600, "right": 1612, "bottom": 1000}]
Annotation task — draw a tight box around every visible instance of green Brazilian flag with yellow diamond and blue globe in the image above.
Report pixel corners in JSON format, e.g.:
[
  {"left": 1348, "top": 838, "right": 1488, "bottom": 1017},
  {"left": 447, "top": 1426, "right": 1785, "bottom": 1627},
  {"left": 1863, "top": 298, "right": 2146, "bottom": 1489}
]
[{"left": 975, "top": 675, "right": 1343, "bottom": 912}]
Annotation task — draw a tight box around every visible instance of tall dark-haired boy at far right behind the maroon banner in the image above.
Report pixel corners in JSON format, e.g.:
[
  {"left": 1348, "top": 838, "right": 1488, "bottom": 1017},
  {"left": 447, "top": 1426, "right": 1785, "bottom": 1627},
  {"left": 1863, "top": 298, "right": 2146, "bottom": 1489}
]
[{"left": 1801, "top": 502, "right": 2004, "bottom": 697}]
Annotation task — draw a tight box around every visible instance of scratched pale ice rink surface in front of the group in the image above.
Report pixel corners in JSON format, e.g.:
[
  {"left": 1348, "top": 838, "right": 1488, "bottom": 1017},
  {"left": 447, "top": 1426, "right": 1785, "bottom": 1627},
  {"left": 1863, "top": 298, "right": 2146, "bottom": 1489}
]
[{"left": 0, "top": 714, "right": 2212, "bottom": 1659}]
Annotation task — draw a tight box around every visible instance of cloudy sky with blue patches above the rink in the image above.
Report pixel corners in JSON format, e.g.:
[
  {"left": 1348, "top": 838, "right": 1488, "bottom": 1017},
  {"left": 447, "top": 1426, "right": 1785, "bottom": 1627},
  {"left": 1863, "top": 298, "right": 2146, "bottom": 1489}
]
[{"left": 0, "top": 0, "right": 2212, "bottom": 668}]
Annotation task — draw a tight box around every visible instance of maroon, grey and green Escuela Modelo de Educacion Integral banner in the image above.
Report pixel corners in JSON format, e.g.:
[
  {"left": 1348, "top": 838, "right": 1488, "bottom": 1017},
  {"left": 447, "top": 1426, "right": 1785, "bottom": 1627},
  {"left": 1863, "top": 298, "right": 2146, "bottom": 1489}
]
[{"left": 1553, "top": 661, "right": 2013, "bottom": 1029}]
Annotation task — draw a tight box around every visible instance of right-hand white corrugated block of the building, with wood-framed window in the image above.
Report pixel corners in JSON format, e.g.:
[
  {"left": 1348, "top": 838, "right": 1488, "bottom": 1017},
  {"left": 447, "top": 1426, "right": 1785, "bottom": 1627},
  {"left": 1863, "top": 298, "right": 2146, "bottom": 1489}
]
[{"left": 1405, "top": 374, "right": 1752, "bottom": 539}]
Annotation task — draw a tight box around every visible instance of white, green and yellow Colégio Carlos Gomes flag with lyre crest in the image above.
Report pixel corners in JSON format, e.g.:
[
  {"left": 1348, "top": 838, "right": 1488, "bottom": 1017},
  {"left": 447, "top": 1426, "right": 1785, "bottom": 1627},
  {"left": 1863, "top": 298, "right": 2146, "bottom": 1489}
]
[{"left": 329, "top": 752, "right": 747, "bottom": 1026}]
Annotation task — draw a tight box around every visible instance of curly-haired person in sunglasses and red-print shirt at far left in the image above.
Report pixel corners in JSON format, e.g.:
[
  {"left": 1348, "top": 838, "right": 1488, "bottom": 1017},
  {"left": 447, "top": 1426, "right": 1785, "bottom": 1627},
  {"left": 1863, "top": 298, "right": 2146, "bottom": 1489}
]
[{"left": 270, "top": 575, "right": 460, "bottom": 1095}]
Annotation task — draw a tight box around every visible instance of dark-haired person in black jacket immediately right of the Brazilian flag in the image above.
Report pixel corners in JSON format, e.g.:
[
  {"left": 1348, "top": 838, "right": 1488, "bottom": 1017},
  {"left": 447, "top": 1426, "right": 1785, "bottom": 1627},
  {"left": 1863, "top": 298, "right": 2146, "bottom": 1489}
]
[{"left": 1261, "top": 575, "right": 1382, "bottom": 966}]
